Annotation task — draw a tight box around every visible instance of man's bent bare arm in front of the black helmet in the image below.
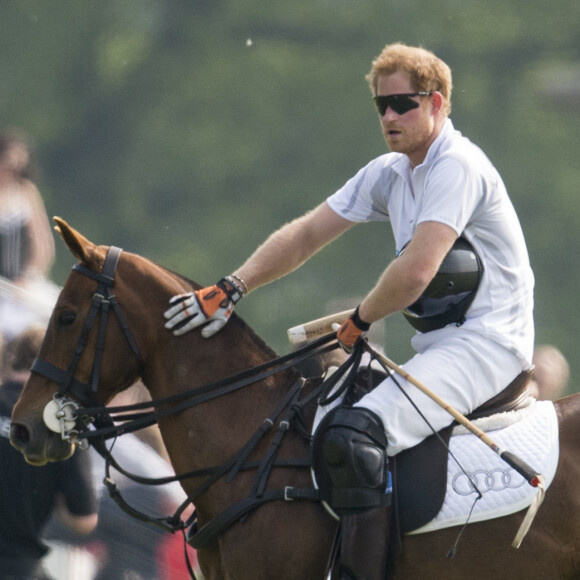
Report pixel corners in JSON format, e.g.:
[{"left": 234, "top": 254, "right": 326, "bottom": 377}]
[{"left": 358, "top": 221, "right": 457, "bottom": 323}]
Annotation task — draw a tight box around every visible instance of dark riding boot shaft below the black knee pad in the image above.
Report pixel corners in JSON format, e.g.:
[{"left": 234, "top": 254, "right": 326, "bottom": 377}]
[{"left": 339, "top": 506, "right": 391, "bottom": 580}]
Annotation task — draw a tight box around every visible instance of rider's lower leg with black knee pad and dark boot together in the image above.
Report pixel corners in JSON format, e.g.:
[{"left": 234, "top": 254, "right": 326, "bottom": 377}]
[{"left": 312, "top": 407, "right": 392, "bottom": 580}]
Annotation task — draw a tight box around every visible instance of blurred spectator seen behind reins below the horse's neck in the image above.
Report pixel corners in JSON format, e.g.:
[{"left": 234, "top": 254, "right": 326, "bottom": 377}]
[{"left": 45, "top": 383, "right": 201, "bottom": 580}]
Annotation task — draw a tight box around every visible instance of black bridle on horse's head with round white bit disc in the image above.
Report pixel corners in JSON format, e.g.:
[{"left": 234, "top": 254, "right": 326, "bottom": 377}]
[{"left": 31, "top": 246, "right": 143, "bottom": 439}]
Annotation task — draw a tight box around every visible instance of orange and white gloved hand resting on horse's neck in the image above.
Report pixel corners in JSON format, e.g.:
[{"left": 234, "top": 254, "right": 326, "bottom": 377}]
[{"left": 164, "top": 277, "right": 243, "bottom": 338}]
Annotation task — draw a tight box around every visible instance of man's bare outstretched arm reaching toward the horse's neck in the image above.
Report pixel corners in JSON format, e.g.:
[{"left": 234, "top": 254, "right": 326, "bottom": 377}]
[{"left": 234, "top": 202, "right": 355, "bottom": 292}]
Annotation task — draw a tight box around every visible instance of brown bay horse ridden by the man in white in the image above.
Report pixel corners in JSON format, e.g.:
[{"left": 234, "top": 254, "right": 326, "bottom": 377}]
[{"left": 11, "top": 218, "right": 580, "bottom": 580}]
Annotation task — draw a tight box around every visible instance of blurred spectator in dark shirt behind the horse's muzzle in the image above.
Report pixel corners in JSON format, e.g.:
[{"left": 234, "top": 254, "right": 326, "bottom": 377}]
[{"left": 0, "top": 328, "right": 98, "bottom": 580}]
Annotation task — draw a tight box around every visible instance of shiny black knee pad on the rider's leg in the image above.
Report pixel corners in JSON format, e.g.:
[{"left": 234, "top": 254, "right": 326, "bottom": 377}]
[{"left": 312, "top": 407, "right": 390, "bottom": 516}]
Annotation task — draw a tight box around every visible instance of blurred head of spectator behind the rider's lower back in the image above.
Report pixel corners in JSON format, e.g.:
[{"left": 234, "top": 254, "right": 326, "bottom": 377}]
[{"left": 528, "top": 344, "right": 570, "bottom": 401}]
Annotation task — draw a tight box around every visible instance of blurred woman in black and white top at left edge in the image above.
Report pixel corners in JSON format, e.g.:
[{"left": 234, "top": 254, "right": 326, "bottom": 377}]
[{"left": 0, "top": 130, "right": 58, "bottom": 338}]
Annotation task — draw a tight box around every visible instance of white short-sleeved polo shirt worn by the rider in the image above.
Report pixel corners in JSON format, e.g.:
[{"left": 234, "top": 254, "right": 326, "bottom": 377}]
[{"left": 327, "top": 119, "right": 534, "bottom": 368}]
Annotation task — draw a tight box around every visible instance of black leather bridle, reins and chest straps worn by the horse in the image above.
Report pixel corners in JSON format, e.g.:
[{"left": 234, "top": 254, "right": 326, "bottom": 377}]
[{"left": 31, "top": 246, "right": 362, "bottom": 564}]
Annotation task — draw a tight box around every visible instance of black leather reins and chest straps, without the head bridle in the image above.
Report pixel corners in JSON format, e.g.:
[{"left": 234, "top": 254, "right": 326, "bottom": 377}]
[{"left": 94, "top": 335, "right": 363, "bottom": 550}]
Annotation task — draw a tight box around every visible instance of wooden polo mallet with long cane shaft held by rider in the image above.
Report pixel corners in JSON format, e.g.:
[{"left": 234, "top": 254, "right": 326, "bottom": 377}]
[{"left": 288, "top": 309, "right": 546, "bottom": 548}]
